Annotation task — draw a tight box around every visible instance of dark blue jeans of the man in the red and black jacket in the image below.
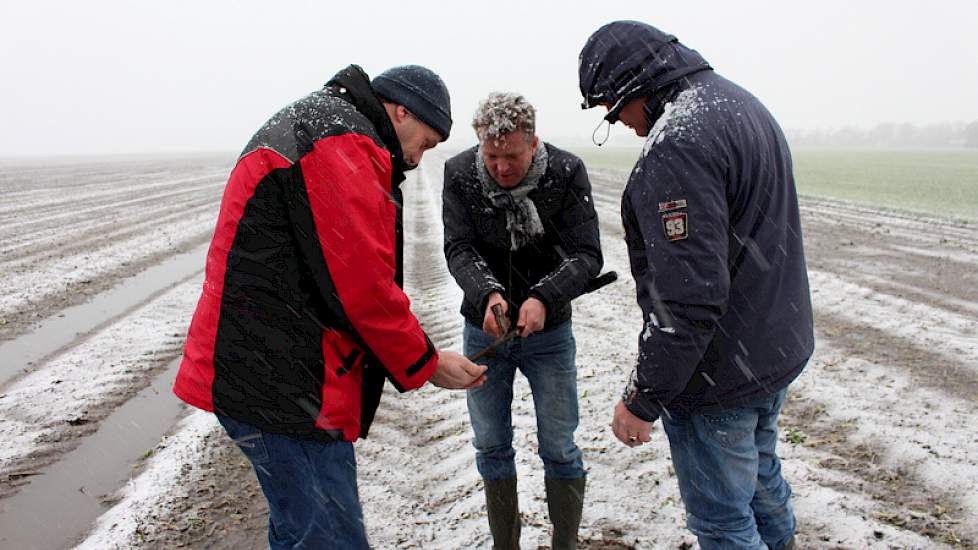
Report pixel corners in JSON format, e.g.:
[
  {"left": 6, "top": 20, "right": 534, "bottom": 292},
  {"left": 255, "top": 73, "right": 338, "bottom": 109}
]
[{"left": 217, "top": 415, "right": 370, "bottom": 550}]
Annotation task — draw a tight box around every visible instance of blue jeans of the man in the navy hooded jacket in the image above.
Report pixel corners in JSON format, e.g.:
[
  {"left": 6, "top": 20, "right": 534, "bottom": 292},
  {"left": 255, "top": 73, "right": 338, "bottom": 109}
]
[{"left": 662, "top": 389, "right": 795, "bottom": 550}]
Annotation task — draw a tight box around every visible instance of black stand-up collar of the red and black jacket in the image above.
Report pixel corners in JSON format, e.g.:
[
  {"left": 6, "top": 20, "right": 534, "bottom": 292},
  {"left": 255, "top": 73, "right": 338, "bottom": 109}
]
[{"left": 326, "top": 65, "right": 410, "bottom": 185}]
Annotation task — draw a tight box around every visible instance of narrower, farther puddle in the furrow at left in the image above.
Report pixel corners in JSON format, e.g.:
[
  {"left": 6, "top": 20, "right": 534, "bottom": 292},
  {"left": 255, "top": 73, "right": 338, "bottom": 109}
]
[{"left": 0, "top": 245, "right": 208, "bottom": 387}]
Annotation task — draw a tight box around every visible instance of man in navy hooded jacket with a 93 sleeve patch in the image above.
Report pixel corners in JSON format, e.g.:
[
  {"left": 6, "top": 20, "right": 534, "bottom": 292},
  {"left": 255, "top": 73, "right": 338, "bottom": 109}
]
[{"left": 580, "top": 21, "right": 814, "bottom": 550}]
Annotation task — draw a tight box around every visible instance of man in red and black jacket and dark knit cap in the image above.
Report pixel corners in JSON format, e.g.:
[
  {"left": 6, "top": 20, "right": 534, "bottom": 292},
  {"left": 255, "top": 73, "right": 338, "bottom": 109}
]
[{"left": 173, "top": 65, "right": 484, "bottom": 548}]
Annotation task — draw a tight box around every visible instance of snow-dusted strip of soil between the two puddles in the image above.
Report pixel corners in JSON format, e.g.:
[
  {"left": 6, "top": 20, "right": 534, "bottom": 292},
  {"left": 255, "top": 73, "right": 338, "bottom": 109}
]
[{"left": 0, "top": 279, "right": 200, "bottom": 496}]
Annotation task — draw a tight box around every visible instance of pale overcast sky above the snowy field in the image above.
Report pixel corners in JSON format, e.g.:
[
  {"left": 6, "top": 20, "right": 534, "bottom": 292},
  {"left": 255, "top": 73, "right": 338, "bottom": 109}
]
[{"left": 0, "top": 0, "right": 978, "bottom": 156}]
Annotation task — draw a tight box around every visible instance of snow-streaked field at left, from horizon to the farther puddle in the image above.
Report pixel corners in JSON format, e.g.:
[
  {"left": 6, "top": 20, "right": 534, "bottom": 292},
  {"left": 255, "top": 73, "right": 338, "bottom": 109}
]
[{"left": 0, "top": 155, "right": 229, "bottom": 342}]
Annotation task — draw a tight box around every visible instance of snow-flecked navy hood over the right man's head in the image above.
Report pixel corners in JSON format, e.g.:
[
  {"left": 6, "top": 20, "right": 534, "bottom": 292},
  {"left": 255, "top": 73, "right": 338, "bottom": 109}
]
[{"left": 578, "top": 21, "right": 712, "bottom": 123}]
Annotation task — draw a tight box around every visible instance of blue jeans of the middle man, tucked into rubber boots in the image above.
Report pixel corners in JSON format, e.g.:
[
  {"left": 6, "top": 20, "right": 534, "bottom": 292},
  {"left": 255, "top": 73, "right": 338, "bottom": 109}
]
[{"left": 463, "top": 321, "right": 585, "bottom": 479}]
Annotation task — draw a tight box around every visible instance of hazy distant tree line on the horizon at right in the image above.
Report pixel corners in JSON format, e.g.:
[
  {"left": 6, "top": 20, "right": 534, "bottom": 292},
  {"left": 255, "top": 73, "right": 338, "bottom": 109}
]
[{"left": 786, "top": 121, "right": 978, "bottom": 149}]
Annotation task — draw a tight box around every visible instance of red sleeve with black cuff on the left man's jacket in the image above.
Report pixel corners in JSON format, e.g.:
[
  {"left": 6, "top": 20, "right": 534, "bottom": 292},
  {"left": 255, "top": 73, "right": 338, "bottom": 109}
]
[{"left": 299, "top": 134, "right": 437, "bottom": 389}]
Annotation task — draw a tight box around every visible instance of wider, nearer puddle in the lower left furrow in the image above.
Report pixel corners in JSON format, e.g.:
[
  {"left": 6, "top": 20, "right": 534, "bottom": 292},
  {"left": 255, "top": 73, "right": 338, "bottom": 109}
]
[{"left": 0, "top": 358, "right": 185, "bottom": 549}]
